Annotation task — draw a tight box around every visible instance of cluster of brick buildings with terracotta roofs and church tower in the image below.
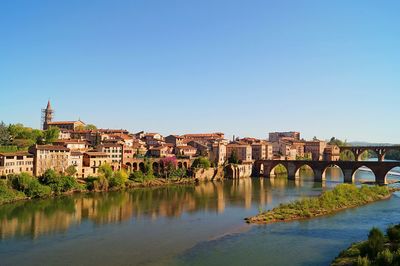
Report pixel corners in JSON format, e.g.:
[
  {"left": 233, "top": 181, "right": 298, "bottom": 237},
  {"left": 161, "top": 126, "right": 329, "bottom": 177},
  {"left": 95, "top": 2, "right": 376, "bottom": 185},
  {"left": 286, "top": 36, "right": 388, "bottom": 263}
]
[{"left": 0, "top": 102, "right": 340, "bottom": 178}]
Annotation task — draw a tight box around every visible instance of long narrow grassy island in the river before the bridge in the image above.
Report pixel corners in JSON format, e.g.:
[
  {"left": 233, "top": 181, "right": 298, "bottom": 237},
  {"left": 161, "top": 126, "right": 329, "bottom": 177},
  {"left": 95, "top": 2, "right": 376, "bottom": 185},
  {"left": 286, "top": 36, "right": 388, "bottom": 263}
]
[{"left": 245, "top": 184, "right": 391, "bottom": 224}]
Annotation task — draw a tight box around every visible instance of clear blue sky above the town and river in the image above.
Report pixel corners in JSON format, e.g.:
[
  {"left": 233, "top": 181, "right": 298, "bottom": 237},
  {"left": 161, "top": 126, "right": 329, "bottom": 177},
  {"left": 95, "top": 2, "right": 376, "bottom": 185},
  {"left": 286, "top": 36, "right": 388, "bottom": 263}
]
[{"left": 0, "top": 0, "right": 400, "bottom": 143}]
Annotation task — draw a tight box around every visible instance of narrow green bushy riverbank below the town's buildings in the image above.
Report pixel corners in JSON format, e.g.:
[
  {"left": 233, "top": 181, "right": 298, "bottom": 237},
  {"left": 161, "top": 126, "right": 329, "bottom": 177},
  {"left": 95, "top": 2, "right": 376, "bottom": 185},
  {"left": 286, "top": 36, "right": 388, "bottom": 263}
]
[{"left": 0, "top": 178, "right": 196, "bottom": 205}]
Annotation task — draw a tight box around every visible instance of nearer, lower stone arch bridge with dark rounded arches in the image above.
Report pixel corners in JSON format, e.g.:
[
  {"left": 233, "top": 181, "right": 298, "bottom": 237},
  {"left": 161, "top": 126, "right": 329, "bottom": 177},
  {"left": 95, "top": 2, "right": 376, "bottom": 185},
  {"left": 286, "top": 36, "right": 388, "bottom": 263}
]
[{"left": 253, "top": 160, "right": 400, "bottom": 184}]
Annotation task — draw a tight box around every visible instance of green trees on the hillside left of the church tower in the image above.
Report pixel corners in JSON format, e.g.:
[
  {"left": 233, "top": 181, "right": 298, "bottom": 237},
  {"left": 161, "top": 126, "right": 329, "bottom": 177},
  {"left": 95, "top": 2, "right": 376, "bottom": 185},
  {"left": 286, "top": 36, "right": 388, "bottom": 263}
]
[{"left": 0, "top": 122, "right": 60, "bottom": 152}]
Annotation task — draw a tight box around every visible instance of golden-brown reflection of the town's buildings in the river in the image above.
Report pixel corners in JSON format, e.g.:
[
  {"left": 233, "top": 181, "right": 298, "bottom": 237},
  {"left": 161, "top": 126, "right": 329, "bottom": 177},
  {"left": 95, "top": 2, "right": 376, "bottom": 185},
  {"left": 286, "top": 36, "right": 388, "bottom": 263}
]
[{"left": 0, "top": 170, "right": 340, "bottom": 239}]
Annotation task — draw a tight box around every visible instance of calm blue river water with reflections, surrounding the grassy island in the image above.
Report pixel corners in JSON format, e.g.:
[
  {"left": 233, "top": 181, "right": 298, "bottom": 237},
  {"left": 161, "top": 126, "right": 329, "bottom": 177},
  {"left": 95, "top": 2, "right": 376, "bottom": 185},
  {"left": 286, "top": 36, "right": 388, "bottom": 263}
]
[{"left": 0, "top": 168, "right": 400, "bottom": 265}]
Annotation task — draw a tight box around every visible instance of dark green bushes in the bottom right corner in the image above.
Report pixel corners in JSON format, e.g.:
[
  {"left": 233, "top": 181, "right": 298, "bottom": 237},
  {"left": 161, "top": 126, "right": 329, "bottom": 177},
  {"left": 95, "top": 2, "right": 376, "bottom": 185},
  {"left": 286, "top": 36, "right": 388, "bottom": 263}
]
[{"left": 331, "top": 224, "right": 400, "bottom": 266}]
